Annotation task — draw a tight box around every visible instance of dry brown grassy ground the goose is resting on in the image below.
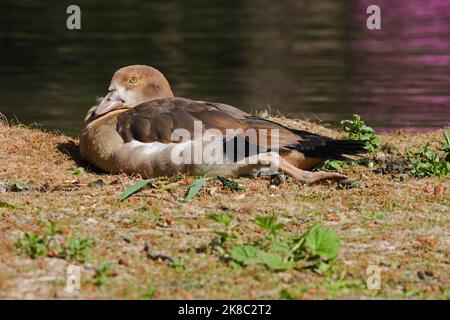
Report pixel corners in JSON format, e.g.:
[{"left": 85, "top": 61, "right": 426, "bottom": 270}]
[{"left": 0, "top": 118, "right": 450, "bottom": 299}]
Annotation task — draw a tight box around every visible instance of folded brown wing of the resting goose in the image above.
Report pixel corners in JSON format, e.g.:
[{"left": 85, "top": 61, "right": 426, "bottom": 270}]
[{"left": 117, "top": 98, "right": 344, "bottom": 156}]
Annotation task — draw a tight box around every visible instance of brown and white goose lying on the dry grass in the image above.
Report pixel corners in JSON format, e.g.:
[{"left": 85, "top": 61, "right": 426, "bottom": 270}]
[{"left": 80, "top": 65, "right": 365, "bottom": 183}]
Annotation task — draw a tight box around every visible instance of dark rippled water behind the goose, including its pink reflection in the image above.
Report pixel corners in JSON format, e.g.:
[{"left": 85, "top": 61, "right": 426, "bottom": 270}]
[{"left": 0, "top": 0, "right": 450, "bottom": 135}]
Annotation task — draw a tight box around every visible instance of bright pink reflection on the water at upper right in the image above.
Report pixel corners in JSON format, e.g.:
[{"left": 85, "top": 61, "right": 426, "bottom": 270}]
[{"left": 351, "top": 0, "right": 450, "bottom": 127}]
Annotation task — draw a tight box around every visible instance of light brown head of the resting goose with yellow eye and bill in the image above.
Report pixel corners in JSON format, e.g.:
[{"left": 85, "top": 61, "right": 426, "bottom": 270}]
[{"left": 95, "top": 65, "right": 173, "bottom": 117}]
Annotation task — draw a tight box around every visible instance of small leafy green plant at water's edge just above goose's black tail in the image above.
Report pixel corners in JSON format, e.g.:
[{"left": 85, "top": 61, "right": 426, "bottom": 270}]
[{"left": 341, "top": 114, "right": 381, "bottom": 153}]
